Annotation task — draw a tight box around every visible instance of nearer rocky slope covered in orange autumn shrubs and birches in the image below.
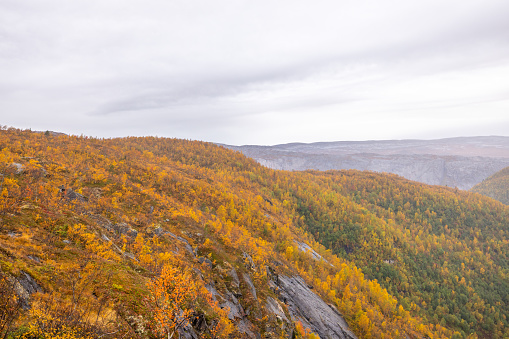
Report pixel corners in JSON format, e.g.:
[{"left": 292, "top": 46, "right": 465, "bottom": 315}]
[{"left": 0, "top": 128, "right": 442, "bottom": 338}]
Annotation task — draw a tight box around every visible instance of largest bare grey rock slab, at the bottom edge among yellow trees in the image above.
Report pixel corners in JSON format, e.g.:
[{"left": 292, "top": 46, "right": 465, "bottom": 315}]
[{"left": 278, "top": 276, "right": 356, "bottom": 339}]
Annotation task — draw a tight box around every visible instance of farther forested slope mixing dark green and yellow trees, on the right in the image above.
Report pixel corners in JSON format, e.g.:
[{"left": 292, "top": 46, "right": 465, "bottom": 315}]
[{"left": 279, "top": 171, "right": 509, "bottom": 338}]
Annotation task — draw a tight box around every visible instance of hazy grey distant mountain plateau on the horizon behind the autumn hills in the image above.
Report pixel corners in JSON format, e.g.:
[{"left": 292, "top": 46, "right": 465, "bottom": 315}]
[{"left": 226, "top": 136, "right": 509, "bottom": 190}]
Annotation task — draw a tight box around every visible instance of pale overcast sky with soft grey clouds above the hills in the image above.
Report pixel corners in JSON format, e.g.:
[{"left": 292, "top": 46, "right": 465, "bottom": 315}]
[{"left": 0, "top": 0, "right": 509, "bottom": 145}]
